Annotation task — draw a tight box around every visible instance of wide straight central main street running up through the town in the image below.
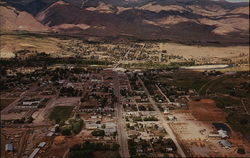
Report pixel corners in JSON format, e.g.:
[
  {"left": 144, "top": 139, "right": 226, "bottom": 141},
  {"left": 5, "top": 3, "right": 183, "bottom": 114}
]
[{"left": 114, "top": 72, "right": 130, "bottom": 158}]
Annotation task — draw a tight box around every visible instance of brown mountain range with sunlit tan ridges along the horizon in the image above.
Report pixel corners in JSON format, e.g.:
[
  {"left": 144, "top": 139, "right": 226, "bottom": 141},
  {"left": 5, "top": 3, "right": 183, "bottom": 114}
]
[{"left": 0, "top": 0, "right": 249, "bottom": 44}]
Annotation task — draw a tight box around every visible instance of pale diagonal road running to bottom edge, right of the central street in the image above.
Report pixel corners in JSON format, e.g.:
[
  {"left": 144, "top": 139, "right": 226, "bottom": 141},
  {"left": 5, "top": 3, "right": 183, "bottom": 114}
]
[{"left": 138, "top": 77, "right": 186, "bottom": 157}]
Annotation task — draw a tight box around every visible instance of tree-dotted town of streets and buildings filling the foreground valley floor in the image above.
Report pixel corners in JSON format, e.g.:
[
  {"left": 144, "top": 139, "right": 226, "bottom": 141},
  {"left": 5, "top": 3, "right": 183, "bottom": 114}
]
[{"left": 1, "top": 58, "right": 250, "bottom": 158}]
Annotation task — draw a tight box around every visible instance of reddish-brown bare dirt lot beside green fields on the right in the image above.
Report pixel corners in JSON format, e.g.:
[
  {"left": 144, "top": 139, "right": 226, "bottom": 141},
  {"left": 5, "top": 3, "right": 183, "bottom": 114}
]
[{"left": 189, "top": 99, "right": 226, "bottom": 122}]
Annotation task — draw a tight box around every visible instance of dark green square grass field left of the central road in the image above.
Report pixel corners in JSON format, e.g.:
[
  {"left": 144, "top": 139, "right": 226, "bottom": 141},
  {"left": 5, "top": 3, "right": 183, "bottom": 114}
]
[{"left": 49, "top": 106, "right": 74, "bottom": 123}]
